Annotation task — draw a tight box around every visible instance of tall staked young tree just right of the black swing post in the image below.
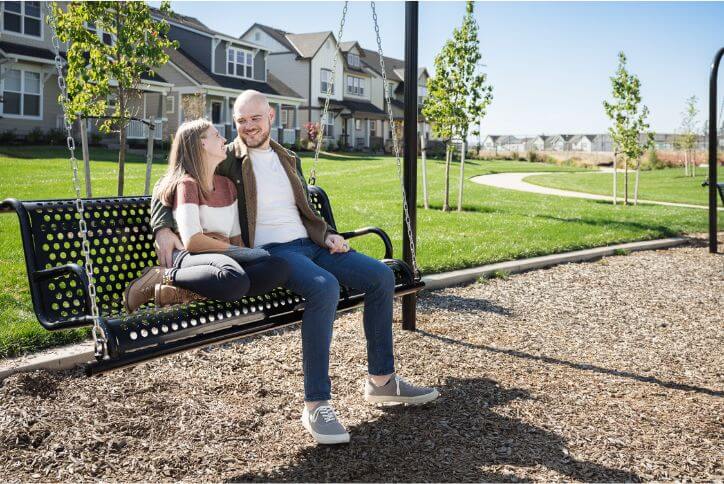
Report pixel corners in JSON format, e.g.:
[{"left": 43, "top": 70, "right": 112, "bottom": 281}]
[{"left": 423, "top": 0, "right": 493, "bottom": 211}]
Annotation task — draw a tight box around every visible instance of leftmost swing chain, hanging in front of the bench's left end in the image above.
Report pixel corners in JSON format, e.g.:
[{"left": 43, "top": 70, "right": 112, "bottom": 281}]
[{"left": 50, "top": 8, "right": 108, "bottom": 358}]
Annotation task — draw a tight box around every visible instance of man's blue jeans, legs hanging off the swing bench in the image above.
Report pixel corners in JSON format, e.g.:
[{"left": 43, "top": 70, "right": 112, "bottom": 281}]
[{"left": 262, "top": 238, "right": 395, "bottom": 402}]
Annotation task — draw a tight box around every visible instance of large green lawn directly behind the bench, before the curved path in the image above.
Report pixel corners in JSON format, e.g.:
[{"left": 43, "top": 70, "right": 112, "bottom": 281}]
[{"left": 0, "top": 147, "right": 720, "bottom": 357}]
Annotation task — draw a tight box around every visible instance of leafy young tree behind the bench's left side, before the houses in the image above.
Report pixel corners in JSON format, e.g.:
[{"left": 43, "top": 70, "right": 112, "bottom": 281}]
[{"left": 49, "top": 1, "right": 176, "bottom": 196}]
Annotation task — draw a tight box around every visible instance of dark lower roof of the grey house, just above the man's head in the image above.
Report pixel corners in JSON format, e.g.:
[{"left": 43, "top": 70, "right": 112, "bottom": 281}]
[{"left": 167, "top": 49, "right": 302, "bottom": 98}]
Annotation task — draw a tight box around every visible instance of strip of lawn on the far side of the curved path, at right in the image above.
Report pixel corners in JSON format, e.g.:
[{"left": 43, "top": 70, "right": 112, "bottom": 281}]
[{"left": 525, "top": 168, "right": 709, "bottom": 205}]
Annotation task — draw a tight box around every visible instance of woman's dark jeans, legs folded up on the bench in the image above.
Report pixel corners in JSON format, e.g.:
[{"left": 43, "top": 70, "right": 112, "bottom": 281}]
[{"left": 169, "top": 250, "right": 289, "bottom": 301}]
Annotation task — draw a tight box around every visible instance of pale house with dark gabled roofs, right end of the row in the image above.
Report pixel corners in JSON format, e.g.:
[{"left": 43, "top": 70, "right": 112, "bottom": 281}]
[{"left": 240, "top": 23, "right": 429, "bottom": 149}]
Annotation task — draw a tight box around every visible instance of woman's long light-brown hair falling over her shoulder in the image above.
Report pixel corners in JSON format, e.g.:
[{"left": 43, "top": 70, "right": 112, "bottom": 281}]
[{"left": 153, "top": 119, "right": 212, "bottom": 207}]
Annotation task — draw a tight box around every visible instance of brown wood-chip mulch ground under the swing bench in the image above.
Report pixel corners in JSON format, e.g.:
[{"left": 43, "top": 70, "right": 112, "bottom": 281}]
[{"left": 0, "top": 242, "right": 724, "bottom": 481}]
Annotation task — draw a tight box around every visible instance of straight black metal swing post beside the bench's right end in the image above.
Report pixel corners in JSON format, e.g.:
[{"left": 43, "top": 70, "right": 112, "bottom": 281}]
[{"left": 402, "top": 1, "right": 419, "bottom": 331}]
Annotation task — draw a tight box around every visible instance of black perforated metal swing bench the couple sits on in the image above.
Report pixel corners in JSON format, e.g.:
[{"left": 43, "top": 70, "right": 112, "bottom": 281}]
[{"left": 0, "top": 186, "right": 424, "bottom": 375}]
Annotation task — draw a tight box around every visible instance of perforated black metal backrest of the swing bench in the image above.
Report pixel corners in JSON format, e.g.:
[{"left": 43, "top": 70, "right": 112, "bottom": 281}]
[{"left": 14, "top": 187, "right": 336, "bottom": 323}]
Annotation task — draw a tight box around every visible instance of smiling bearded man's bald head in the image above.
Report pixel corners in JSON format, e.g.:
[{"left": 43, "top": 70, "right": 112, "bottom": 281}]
[{"left": 234, "top": 89, "right": 275, "bottom": 148}]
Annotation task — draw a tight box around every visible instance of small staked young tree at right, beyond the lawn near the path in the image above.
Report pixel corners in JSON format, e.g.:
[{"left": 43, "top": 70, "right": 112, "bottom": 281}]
[{"left": 603, "top": 52, "right": 653, "bottom": 205}]
